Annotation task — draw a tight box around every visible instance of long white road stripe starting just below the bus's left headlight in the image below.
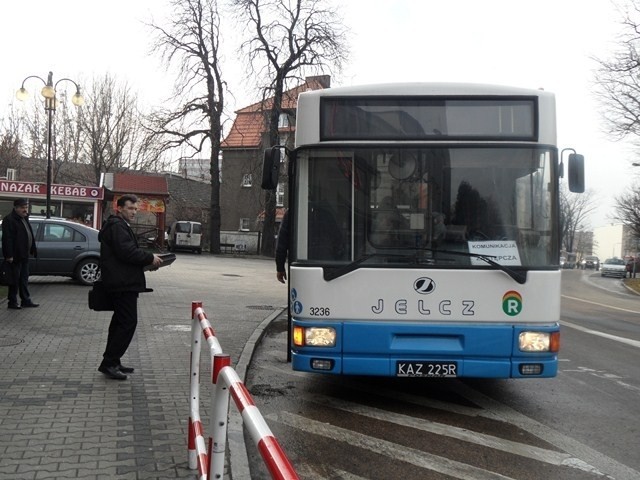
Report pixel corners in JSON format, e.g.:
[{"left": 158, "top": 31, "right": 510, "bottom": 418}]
[{"left": 310, "top": 395, "right": 602, "bottom": 475}]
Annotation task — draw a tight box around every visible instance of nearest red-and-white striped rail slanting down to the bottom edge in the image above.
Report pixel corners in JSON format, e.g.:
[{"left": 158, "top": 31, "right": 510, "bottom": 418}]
[{"left": 213, "top": 355, "right": 299, "bottom": 480}]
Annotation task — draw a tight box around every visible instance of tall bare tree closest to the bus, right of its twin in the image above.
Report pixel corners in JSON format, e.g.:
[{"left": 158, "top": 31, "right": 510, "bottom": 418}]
[{"left": 232, "top": 0, "right": 347, "bottom": 256}]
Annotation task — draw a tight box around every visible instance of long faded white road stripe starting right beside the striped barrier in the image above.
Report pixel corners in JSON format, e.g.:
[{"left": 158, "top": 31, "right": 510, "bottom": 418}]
[{"left": 266, "top": 412, "right": 513, "bottom": 480}]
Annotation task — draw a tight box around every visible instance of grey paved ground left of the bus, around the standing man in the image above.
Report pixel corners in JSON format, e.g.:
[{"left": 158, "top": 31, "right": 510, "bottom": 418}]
[{"left": 0, "top": 254, "right": 287, "bottom": 480}]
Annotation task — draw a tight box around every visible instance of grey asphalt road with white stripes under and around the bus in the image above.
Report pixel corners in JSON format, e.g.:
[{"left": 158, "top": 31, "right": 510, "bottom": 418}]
[{"left": 247, "top": 270, "right": 640, "bottom": 480}]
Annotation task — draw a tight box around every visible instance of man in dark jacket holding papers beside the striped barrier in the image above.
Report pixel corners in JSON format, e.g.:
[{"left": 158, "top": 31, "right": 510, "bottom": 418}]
[{"left": 98, "top": 195, "right": 162, "bottom": 380}]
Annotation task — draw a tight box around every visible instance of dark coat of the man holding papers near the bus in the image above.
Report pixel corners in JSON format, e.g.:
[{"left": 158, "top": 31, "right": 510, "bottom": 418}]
[{"left": 98, "top": 215, "right": 153, "bottom": 292}]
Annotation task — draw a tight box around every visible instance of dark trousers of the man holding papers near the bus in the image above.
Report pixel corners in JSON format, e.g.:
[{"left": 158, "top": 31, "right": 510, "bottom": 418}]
[{"left": 102, "top": 292, "right": 138, "bottom": 368}]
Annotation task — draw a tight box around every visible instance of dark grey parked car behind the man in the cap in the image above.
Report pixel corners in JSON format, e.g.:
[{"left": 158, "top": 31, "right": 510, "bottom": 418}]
[{"left": 0, "top": 216, "right": 100, "bottom": 285}]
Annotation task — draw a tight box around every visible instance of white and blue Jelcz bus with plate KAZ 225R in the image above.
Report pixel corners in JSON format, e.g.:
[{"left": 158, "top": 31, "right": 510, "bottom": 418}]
[{"left": 263, "top": 83, "right": 584, "bottom": 378}]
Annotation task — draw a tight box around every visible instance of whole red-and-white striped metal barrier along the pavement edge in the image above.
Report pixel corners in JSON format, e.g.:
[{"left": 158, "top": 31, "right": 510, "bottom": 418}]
[{"left": 188, "top": 302, "right": 299, "bottom": 480}]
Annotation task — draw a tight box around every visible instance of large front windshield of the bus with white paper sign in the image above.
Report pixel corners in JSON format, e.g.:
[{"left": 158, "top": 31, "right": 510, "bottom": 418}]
[{"left": 292, "top": 146, "right": 558, "bottom": 269}]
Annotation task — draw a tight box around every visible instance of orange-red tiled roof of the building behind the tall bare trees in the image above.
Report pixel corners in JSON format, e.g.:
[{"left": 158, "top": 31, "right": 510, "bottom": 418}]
[{"left": 222, "top": 75, "right": 330, "bottom": 148}]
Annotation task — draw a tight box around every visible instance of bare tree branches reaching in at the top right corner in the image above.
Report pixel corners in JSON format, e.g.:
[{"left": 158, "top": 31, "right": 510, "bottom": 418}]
[{"left": 595, "top": 0, "right": 640, "bottom": 145}]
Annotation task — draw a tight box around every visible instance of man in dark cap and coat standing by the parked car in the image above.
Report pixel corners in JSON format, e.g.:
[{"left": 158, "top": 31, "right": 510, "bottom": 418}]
[{"left": 2, "top": 198, "right": 39, "bottom": 310}]
